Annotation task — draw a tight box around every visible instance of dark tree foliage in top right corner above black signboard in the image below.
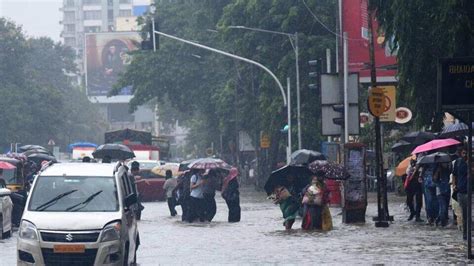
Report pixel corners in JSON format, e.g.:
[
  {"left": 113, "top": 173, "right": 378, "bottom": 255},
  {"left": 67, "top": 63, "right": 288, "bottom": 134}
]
[{"left": 371, "top": 0, "right": 474, "bottom": 126}]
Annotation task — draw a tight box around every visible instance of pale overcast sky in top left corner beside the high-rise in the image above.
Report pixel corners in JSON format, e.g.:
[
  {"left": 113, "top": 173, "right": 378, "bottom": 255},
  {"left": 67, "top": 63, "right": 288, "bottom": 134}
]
[{"left": 0, "top": 0, "right": 63, "bottom": 41}]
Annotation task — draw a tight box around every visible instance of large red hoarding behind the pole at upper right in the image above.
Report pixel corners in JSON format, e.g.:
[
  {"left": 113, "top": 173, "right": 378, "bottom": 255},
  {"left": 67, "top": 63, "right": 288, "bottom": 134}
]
[{"left": 342, "top": 0, "right": 397, "bottom": 82}]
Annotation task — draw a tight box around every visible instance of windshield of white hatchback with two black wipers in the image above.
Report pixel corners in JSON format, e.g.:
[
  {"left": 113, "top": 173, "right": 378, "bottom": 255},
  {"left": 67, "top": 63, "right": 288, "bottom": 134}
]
[{"left": 28, "top": 176, "right": 119, "bottom": 212}]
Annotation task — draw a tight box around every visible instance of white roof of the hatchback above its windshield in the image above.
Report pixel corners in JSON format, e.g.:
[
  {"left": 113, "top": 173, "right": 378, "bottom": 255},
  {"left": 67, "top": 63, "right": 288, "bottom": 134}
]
[{"left": 40, "top": 163, "right": 115, "bottom": 177}]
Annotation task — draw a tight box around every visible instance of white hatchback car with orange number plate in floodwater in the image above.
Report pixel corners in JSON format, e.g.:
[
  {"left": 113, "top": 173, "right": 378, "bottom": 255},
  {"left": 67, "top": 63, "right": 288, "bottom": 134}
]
[{"left": 17, "top": 163, "right": 140, "bottom": 265}]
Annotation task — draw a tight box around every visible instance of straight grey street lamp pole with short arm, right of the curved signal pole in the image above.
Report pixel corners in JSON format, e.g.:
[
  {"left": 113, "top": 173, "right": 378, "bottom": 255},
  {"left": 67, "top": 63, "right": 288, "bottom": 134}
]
[{"left": 227, "top": 26, "right": 302, "bottom": 150}]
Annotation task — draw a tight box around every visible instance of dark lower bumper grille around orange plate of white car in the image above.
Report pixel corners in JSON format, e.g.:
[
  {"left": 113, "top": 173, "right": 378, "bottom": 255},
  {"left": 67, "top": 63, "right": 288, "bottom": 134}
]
[{"left": 41, "top": 248, "right": 97, "bottom": 266}]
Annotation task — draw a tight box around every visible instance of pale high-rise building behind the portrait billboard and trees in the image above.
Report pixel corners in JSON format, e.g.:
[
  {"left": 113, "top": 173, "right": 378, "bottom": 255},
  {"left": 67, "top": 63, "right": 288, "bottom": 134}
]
[{"left": 60, "top": 0, "right": 157, "bottom": 133}]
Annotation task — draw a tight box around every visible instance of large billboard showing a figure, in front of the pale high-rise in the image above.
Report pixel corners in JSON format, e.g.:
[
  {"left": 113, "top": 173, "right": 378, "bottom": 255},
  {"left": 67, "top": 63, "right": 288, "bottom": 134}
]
[{"left": 85, "top": 32, "right": 141, "bottom": 96}]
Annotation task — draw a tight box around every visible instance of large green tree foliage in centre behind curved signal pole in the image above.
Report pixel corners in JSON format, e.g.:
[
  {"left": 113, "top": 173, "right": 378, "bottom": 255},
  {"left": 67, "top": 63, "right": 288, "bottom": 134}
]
[{"left": 112, "top": 0, "right": 336, "bottom": 170}]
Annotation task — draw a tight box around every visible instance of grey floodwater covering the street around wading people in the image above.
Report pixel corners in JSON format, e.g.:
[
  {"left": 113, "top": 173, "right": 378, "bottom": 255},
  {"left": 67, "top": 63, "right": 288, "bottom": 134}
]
[{"left": 0, "top": 190, "right": 467, "bottom": 265}]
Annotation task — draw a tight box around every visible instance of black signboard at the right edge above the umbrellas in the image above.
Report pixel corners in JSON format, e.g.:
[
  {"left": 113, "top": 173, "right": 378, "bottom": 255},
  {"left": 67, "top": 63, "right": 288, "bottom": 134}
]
[{"left": 438, "top": 57, "right": 474, "bottom": 111}]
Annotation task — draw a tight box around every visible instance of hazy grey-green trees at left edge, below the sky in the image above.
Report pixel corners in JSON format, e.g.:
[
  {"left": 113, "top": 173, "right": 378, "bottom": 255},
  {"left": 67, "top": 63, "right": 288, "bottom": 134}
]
[{"left": 0, "top": 18, "right": 104, "bottom": 152}]
